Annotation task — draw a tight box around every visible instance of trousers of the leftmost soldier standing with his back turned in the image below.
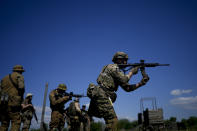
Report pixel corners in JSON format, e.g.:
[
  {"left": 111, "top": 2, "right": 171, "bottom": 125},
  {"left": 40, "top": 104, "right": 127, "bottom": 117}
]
[{"left": 0, "top": 107, "right": 21, "bottom": 131}]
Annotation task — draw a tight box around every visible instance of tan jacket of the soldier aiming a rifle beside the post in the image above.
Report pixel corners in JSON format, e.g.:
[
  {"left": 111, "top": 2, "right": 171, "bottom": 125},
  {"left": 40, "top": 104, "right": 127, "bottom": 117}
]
[{"left": 49, "top": 89, "right": 69, "bottom": 112}]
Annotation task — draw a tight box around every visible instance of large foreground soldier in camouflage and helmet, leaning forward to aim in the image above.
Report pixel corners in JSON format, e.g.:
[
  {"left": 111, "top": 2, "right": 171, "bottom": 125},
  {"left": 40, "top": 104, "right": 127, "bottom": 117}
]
[{"left": 88, "top": 52, "right": 149, "bottom": 131}]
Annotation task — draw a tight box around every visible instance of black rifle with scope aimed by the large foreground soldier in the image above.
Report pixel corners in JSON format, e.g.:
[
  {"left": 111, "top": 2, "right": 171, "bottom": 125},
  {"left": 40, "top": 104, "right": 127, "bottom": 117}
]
[{"left": 119, "top": 60, "right": 170, "bottom": 72}]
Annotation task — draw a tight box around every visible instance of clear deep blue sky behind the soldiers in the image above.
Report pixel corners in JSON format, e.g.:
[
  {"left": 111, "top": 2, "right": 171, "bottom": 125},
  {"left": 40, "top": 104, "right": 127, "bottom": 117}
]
[{"left": 0, "top": 0, "right": 197, "bottom": 127}]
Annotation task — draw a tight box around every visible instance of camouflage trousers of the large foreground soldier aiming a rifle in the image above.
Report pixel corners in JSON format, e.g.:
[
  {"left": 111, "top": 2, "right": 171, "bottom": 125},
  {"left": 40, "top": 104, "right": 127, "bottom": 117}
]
[{"left": 88, "top": 88, "right": 118, "bottom": 131}]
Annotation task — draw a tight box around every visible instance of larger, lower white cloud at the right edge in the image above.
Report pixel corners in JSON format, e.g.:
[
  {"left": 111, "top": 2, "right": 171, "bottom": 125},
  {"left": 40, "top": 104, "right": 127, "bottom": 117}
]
[{"left": 170, "top": 96, "right": 197, "bottom": 110}]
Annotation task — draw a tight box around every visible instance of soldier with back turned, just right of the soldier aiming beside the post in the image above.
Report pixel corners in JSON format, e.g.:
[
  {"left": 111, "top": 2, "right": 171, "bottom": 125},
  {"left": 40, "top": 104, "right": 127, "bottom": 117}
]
[{"left": 68, "top": 97, "right": 81, "bottom": 131}]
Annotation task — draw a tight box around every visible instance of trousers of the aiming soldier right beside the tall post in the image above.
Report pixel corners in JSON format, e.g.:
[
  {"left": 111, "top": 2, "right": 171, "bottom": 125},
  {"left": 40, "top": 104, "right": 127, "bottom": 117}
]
[{"left": 49, "top": 111, "right": 65, "bottom": 131}]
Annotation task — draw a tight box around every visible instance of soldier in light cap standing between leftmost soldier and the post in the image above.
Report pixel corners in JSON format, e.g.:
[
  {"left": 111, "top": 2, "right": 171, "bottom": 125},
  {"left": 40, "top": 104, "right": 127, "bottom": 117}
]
[{"left": 21, "top": 93, "right": 35, "bottom": 131}]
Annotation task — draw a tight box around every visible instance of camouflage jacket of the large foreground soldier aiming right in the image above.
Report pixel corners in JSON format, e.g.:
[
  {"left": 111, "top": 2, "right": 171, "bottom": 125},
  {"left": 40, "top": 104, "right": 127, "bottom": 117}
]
[{"left": 97, "top": 64, "right": 132, "bottom": 92}]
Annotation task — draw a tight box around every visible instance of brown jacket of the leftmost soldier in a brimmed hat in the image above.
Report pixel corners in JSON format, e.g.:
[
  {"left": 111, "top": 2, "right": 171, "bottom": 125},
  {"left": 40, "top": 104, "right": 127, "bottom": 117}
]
[{"left": 1, "top": 72, "right": 25, "bottom": 106}]
